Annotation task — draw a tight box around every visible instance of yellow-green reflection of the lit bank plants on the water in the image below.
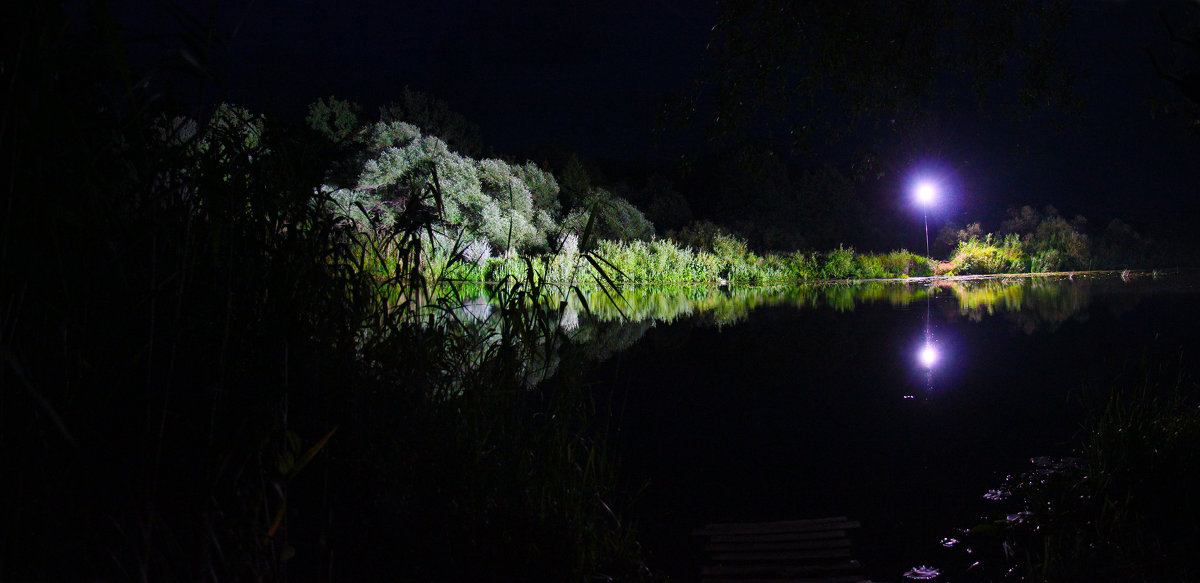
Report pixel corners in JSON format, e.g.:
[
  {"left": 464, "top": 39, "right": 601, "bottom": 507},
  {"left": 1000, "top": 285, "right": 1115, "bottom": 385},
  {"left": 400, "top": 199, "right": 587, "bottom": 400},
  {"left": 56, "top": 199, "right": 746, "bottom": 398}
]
[{"left": 455, "top": 276, "right": 1152, "bottom": 386}]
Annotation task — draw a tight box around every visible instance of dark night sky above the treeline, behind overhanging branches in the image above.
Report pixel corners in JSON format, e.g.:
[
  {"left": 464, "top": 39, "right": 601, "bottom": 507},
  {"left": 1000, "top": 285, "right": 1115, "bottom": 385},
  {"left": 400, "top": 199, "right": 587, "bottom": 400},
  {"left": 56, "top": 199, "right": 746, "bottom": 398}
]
[{"left": 116, "top": 0, "right": 1200, "bottom": 235}]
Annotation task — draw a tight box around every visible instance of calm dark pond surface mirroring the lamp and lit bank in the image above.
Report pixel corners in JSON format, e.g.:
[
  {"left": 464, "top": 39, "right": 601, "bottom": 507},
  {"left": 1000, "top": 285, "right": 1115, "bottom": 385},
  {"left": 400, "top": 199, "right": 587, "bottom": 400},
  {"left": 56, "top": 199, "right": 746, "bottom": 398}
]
[{"left": 564, "top": 274, "right": 1200, "bottom": 581}]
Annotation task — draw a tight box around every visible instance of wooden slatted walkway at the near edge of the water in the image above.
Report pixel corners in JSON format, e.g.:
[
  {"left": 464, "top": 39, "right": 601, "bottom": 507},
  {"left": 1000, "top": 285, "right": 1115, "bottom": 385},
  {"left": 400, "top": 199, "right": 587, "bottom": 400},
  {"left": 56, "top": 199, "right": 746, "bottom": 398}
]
[{"left": 692, "top": 516, "right": 865, "bottom": 583}]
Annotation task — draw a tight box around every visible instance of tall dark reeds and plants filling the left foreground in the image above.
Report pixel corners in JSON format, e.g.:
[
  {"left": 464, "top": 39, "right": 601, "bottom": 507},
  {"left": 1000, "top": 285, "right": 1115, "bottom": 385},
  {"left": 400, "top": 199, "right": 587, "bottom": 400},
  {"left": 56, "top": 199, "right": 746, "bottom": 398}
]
[{"left": 0, "top": 2, "right": 646, "bottom": 581}]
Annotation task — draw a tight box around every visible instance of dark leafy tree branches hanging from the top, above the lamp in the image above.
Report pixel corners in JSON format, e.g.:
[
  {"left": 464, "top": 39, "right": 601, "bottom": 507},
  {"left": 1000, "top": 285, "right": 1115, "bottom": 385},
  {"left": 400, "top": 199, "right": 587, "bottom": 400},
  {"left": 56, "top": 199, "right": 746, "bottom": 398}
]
[{"left": 670, "top": 0, "right": 1075, "bottom": 149}]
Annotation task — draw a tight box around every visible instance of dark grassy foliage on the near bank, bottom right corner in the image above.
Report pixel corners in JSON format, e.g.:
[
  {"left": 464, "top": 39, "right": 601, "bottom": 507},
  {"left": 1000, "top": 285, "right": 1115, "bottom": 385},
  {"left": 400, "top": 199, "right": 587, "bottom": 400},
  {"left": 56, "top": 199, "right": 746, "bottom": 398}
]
[{"left": 972, "top": 371, "right": 1200, "bottom": 582}]
